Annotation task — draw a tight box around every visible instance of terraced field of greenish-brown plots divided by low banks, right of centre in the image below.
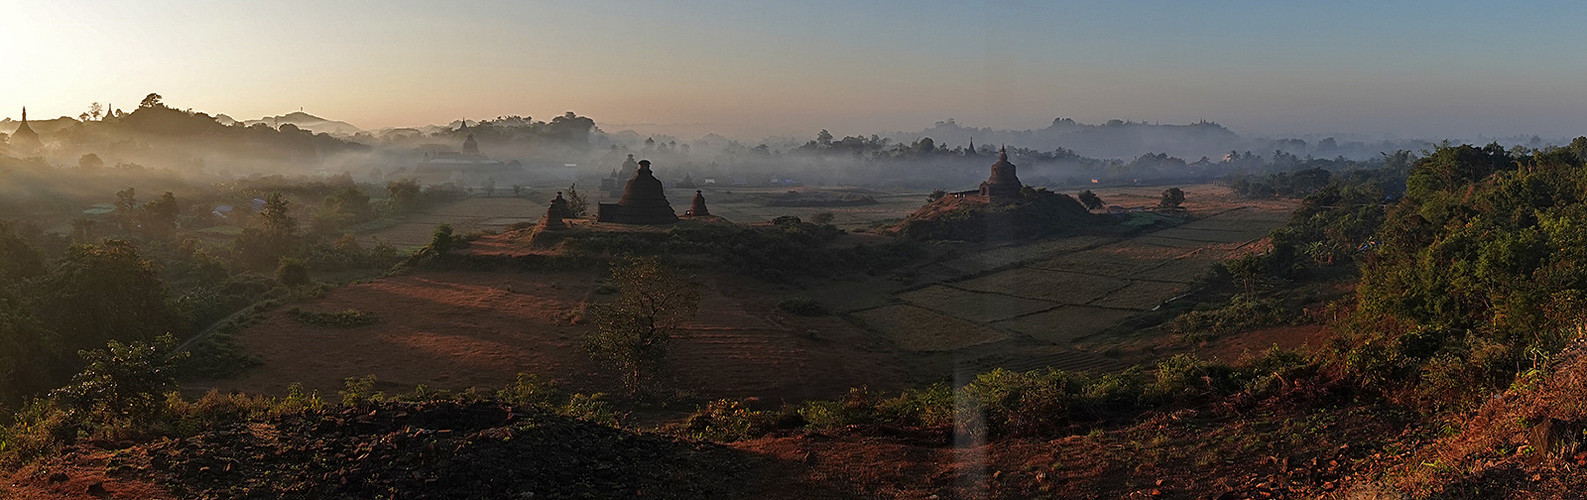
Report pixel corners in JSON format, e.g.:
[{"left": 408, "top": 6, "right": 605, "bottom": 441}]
[{"left": 849, "top": 206, "right": 1289, "bottom": 376}]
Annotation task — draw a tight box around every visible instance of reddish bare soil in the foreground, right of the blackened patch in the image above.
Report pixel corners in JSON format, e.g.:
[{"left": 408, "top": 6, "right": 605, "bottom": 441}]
[{"left": 733, "top": 387, "right": 1404, "bottom": 498}]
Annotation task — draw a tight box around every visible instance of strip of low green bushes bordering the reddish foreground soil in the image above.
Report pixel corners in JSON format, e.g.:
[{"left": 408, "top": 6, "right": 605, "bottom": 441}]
[{"left": 673, "top": 349, "right": 1316, "bottom": 441}]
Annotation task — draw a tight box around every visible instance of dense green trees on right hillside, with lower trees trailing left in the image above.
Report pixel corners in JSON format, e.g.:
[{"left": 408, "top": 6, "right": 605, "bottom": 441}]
[{"left": 1199, "top": 138, "right": 1587, "bottom": 413}]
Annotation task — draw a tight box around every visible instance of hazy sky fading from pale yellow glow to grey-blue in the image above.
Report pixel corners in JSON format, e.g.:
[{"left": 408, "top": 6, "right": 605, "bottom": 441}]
[{"left": 0, "top": 0, "right": 1587, "bottom": 140}]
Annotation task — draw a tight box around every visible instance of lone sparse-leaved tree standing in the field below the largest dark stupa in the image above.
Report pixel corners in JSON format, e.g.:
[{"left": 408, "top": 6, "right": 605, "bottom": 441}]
[{"left": 586, "top": 257, "right": 700, "bottom": 395}]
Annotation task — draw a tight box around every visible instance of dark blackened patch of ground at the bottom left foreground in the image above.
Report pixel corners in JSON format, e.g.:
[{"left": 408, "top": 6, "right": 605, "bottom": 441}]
[{"left": 111, "top": 402, "right": 806, "bottom": 498}]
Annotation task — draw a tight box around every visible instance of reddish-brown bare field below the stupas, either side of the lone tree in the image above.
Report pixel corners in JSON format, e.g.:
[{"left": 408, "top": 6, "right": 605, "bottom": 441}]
[{"left": 196, "top": 271, "right": 909, "bottom": 402}]
